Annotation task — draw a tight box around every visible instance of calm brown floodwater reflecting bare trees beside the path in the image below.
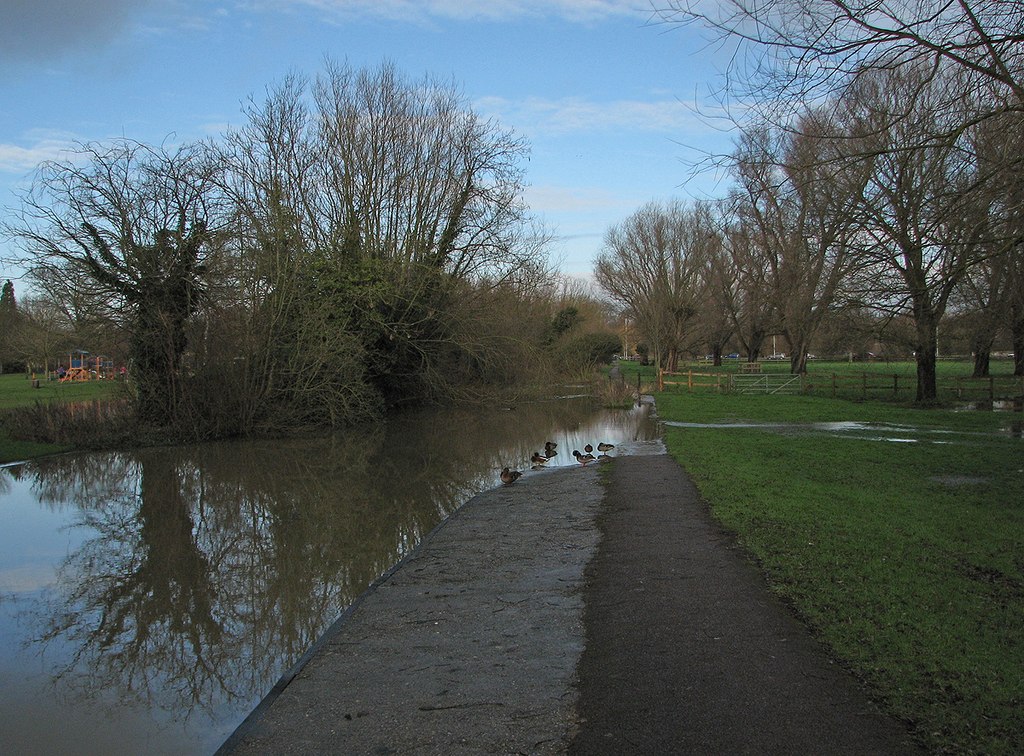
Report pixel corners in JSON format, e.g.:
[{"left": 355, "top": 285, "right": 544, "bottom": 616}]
[{"left": 0, "top": 400, "right": 657, "bottom": 754}]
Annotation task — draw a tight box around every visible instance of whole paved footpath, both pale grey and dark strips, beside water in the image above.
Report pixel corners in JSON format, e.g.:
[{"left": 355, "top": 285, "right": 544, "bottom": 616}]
[{"left": 222, "top": 445, "right": 914, "bottom": 754}]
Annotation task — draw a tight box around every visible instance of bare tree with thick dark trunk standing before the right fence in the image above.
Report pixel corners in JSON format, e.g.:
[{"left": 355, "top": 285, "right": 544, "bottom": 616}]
[{"left": 848, "top": 68, "right": 986, "bottom": 402}]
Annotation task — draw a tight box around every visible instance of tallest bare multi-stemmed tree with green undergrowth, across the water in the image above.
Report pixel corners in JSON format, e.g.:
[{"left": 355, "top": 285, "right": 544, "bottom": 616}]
[{"left": 210, "top": 58, "right": 546, "bottom": 424}]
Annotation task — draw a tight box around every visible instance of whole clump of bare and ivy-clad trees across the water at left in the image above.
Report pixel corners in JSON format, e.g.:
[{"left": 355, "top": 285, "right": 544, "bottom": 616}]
[{"left": 6, "top": 62, "right": 618, "bottom": 437}]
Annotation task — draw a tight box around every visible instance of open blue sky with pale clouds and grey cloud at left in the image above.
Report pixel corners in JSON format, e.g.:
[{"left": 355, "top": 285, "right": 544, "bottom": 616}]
[{"left": 0, "top": 0, "right": 731, "bottom": 279}]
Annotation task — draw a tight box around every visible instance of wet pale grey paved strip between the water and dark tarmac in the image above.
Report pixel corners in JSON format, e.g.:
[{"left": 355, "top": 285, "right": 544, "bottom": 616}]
[{"left": 220, "top": 465, "right": 602, "bottom": 754}]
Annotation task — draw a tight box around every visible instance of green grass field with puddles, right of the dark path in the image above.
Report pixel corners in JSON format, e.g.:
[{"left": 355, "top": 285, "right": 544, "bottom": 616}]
[{"left": 657, "top": 392, "right": 1024, "bottom": 753}]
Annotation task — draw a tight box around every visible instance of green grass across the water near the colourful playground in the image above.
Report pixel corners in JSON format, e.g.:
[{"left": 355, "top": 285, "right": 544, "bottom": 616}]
[{"left": 0, "top": 374, "right": 123, "bottom": 464}]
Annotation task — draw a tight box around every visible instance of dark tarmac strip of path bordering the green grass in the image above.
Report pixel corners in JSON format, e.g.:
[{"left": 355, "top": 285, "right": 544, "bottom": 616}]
[{"left": 570, "top": 455, "right": 915, "bottom": 754}]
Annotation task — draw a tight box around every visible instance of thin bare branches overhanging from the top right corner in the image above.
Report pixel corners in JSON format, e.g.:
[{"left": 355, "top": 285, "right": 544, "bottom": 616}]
[{"left": 652, "top": 0, "right": 1024, "bottom": 110}]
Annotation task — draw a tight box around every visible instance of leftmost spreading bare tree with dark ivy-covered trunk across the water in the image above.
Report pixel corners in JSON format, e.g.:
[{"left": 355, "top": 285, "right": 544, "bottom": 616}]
[{"left": 8, "top": 139, "right": 224, "bottom": 424}]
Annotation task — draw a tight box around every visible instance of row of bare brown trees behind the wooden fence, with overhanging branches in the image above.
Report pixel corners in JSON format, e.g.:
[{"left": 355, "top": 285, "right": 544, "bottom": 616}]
[{"left": 595, "top": 0, "right": 1024, "bottom": 401}]
